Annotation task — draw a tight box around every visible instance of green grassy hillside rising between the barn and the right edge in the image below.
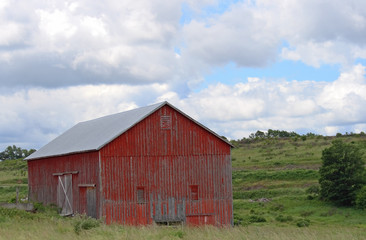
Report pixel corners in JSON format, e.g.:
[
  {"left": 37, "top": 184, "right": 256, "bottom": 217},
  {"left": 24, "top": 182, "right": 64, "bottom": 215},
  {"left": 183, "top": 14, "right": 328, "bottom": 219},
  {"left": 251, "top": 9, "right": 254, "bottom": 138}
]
[{"left": 232, "top": 135, "right": 366, "bottom": 226}]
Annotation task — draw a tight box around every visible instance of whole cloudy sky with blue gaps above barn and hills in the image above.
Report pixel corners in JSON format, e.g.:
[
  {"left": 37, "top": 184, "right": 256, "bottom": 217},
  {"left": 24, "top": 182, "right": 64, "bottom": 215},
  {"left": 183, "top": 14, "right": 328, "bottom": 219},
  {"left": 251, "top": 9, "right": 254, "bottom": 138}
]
[{"left": 0, "top": 0, "right": 366, "bottom": 150}]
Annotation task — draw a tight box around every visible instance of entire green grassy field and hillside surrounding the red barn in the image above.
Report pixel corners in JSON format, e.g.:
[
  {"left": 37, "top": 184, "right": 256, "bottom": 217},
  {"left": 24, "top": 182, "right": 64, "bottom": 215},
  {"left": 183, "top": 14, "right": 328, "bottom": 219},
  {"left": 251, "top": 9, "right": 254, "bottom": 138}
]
[{"left": 0, "top": 135, "right": 366, "bottom": 239}]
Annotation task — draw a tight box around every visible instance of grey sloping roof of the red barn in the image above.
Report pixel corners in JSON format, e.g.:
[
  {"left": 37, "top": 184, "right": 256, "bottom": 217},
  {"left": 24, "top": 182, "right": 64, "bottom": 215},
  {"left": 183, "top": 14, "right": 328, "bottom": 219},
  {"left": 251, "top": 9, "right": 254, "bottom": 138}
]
[{"left": 25, "top": 102, "right": 232, "bottom": 160}]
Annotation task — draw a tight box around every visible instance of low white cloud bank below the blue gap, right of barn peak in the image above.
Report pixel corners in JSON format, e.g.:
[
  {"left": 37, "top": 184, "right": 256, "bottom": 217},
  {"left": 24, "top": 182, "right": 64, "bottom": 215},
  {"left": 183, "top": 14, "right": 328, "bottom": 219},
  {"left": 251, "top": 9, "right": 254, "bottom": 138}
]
[{"left": 170, "top": 65, "right": 366, "bottom": 139}]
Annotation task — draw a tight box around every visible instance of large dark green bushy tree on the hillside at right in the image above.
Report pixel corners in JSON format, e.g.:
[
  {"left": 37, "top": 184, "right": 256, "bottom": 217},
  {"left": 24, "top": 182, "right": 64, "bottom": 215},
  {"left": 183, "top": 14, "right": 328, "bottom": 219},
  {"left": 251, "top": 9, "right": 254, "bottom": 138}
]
[{"left": 319, "top": 140, "right": 366, "bottom": 206}]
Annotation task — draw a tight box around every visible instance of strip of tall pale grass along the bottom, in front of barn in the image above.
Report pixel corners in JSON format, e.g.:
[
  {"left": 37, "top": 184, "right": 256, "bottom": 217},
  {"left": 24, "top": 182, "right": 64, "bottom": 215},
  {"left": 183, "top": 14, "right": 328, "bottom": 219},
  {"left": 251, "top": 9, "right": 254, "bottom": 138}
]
[{"left": 0, "top": 208, "right": 366, "bottom": 240}]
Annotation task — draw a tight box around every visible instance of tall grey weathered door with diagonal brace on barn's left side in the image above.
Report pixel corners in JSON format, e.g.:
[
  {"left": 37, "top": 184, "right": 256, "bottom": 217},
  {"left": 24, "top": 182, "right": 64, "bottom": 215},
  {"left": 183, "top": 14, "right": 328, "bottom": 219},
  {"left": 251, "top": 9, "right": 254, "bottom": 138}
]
[{"left": 57, "top": 174, "right": 73, "bottom": 216}]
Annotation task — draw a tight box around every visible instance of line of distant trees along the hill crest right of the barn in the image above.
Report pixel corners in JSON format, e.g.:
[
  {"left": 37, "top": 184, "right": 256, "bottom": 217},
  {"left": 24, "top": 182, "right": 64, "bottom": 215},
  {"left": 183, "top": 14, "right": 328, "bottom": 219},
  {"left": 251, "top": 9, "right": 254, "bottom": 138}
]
[{"left": 231, "top": 129, "right": 366, "bottom": 144}]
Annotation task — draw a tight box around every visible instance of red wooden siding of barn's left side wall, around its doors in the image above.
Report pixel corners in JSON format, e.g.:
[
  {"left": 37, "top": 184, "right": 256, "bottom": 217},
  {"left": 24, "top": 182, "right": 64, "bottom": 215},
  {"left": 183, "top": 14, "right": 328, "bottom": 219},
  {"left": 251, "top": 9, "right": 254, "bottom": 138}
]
[{"left": 28, "top": 151, "right": 99, "bottom": 217}]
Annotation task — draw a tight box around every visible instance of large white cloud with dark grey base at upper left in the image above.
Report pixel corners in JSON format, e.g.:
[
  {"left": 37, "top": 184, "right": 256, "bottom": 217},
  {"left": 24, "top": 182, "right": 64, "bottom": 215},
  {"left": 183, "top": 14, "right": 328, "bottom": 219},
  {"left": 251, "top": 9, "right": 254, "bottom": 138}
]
[{"left": 0, "top": 0, "right": 186, "bottom": 87}]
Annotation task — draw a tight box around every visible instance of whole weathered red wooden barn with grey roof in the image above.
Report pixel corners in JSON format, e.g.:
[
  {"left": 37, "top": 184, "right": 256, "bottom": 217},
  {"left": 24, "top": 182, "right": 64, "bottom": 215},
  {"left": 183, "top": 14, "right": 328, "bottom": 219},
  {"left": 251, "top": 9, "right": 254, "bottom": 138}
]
[{"left": 26, "top": 102, "right": 233, "bottom": 226}]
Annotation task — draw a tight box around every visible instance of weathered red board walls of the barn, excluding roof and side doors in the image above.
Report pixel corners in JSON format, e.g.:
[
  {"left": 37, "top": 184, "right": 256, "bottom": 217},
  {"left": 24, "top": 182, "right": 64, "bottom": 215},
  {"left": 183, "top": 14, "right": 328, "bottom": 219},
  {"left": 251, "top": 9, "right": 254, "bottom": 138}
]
[{"left": 28, "top": 105, "right": 233, "bottom": 225}]
